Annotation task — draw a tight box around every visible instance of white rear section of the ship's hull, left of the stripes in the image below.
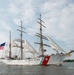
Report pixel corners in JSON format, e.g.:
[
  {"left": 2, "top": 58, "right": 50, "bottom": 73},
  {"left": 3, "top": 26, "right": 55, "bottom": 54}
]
[{"left": 3, "top": 59, "right": 41, "bottom": 65}]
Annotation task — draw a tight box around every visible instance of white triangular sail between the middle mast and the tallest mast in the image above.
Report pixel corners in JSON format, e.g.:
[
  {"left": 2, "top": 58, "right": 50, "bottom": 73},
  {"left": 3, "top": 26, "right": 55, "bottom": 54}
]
[{"left": 24, "top": 40, "right": 39, "bottom": 54}]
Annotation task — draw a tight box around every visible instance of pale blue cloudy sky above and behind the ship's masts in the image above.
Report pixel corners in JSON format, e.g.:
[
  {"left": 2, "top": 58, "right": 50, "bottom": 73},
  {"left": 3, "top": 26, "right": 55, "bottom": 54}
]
[{"left": 0, "top": 0, "right": 74, "bottom": 58}]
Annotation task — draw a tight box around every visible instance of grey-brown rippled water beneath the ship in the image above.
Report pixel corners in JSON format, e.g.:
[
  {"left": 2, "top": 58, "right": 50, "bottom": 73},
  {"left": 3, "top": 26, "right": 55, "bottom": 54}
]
[{"left": 0, "top": 62, "right": 74, "bottom": 75}]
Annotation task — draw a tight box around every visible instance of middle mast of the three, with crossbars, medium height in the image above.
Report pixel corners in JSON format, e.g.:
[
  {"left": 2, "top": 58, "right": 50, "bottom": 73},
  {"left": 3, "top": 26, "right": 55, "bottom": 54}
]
[{"left": 17, "top": 21, "right": 26, "bottom": 60}]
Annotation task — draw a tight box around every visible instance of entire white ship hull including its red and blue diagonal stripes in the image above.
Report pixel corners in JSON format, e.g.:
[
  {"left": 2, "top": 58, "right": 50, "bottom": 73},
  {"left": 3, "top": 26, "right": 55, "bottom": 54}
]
[{"left": 2, "top": 54, "right": 65, "bottom": 65}]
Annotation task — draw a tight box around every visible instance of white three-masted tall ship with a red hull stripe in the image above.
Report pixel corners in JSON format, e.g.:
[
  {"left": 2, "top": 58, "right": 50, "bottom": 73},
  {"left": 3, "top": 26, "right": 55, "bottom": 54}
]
[{"left": 2, "top": 15, "right": 74, "bottom": 65}]
